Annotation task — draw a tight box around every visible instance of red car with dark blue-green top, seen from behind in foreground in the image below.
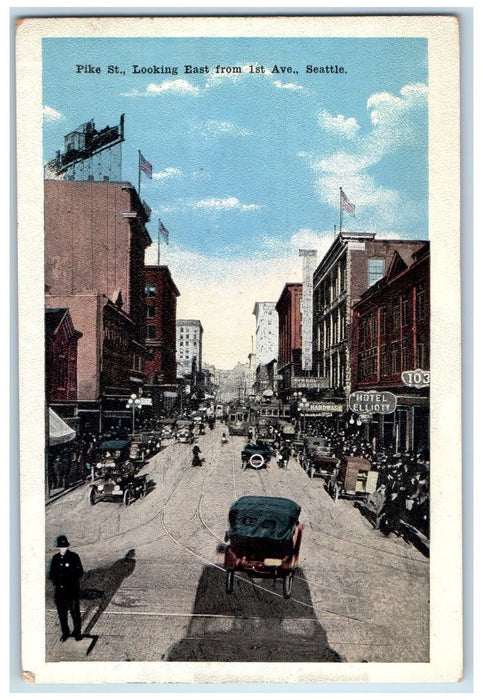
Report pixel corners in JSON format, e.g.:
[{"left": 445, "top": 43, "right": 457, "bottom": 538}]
[{"left": 224, "top": 496, "right": 305, "bottom": 598}]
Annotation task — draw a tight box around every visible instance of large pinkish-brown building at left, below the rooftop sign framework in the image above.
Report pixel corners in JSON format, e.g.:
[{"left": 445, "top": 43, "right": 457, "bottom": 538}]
[{"left": 44, "top": 180, "right": 151, "bottom": 429}]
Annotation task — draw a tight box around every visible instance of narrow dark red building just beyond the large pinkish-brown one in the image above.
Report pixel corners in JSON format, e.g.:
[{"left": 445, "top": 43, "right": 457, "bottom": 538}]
[{"left": 144, "top": 265, "right": 180, "bottom": 385}]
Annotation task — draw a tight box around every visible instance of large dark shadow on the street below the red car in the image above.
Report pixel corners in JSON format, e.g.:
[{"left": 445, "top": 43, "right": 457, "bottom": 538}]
[{"left": 166, "top": 566, "right": 344, "bottom": 662}]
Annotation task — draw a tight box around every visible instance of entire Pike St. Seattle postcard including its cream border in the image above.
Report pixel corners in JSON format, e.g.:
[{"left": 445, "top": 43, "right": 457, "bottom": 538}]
[{"left": 16, "top": 15, "right": 463, "bottom": 689}]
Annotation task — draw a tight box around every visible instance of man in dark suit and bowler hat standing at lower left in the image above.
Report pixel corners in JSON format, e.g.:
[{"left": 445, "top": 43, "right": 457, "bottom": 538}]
[{"left": 49, "top": 535, "right": 84, "bottom": 642}]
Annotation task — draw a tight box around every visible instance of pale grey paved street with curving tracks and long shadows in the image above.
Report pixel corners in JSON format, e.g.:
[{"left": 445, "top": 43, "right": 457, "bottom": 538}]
[{"left": 46, "top": 424, "right": 429, "bottom": 662}]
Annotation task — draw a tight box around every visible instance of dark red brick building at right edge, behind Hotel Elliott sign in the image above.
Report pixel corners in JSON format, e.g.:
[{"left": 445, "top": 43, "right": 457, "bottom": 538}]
[{"left": 352, "top": 243, "right": 430, "bottom": 452}]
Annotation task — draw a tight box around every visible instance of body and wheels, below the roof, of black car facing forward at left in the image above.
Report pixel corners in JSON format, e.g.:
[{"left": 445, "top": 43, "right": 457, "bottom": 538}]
[{"left": 89, "top": 462, "right": 148, "bottom": 506}]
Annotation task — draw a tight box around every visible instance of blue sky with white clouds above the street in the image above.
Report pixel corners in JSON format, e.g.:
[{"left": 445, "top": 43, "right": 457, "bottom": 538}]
[{"left": 43, "top": 38, "right": 428, "bottom": 368}]
